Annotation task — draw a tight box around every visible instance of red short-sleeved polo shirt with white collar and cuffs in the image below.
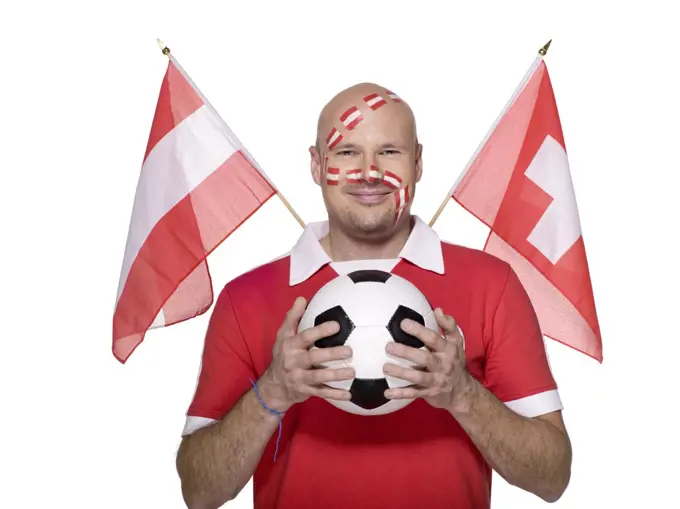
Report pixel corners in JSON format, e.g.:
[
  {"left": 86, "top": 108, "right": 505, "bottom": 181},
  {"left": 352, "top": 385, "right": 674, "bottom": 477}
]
[{"left": 184, "top": 218, "right": 562, "bottom": 509}]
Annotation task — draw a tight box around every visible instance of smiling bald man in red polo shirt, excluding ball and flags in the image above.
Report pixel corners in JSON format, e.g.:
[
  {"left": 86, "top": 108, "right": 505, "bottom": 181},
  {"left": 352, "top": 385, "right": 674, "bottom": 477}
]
[{"left": 177, "top": 84, "right": 571, "bottom": 509}]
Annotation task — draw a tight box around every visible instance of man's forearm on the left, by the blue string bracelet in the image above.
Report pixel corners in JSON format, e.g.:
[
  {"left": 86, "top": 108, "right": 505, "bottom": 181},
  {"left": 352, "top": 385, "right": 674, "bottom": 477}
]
[{"left": 177, "top": 384, "right": 279, "bottom": 509}]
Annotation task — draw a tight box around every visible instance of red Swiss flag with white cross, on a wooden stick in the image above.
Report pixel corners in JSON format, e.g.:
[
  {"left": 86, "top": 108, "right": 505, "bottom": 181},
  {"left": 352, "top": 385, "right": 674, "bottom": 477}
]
[{"left": 451, "top": 57, "right": 602, "bottom": 362}]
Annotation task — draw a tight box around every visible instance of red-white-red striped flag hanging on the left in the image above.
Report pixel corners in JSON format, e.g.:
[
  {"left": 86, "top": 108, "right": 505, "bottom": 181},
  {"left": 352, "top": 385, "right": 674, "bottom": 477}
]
[{"left": 113, "top": 55, "right": 276, "bottom": 363}]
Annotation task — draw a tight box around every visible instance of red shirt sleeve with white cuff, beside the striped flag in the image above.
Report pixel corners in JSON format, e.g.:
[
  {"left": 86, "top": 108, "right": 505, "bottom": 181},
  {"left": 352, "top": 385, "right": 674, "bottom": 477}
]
[{"left": 182, "top": 287, "right": 255, "bottom": 435}]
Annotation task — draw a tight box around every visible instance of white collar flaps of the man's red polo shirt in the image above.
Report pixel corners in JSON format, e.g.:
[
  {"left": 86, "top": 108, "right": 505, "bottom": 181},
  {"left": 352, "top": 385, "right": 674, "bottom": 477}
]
[{"left": 289, "top": 216, "right": 444, "bottom": 286}]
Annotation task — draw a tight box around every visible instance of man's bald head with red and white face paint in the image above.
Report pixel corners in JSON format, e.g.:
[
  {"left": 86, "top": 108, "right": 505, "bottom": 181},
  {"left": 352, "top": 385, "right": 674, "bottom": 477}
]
[{"left": 309, "top": 83, "right": 422, "bottom": 237}]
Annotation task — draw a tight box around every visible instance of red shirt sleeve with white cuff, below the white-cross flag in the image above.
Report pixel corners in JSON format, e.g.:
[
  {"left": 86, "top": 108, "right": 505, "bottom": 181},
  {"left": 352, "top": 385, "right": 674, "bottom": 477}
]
[{"left": 485, "top": 266, "right": 563, "bottom": 417}]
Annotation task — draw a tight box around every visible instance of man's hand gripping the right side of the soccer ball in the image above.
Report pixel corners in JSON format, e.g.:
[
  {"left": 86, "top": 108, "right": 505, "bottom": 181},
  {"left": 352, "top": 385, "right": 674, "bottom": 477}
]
[{"left": 384, "top": 308, "right": 472, "bottom": 410}]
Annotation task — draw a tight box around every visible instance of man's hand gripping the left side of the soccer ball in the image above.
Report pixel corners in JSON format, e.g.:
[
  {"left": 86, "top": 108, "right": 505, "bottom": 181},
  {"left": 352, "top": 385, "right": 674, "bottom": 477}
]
[{"left": 258, "top": 297, "right": 355, "bottom": 412}]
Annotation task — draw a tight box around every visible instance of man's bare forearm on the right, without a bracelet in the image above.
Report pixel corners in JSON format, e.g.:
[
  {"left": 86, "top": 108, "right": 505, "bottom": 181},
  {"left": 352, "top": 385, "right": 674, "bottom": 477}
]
[{"left": 451, "top": 379, "right": 571, "bottom": 502}]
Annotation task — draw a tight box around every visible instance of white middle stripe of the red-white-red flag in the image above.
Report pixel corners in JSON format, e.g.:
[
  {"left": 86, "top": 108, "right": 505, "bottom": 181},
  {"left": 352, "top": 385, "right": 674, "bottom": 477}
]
[{"left": 116, "top": 105, "right": 239, "bottom": 303}]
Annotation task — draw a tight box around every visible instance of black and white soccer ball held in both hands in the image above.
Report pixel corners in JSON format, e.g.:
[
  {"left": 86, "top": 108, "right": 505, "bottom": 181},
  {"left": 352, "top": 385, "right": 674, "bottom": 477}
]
[{"left": 298, "top": 270, "right": 439, "bottom": 415}]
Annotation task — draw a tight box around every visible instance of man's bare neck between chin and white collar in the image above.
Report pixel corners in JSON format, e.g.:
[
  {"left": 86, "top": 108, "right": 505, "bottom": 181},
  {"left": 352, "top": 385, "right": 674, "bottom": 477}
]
[{"left": 320, "top": 217, "right": 413, "bottom": 262}]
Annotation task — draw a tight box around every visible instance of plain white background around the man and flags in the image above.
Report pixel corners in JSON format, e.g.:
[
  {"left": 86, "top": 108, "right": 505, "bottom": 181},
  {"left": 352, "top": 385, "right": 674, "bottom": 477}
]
[{"left": 0, "top": 0, "right": 680, "bottom": 509}]
